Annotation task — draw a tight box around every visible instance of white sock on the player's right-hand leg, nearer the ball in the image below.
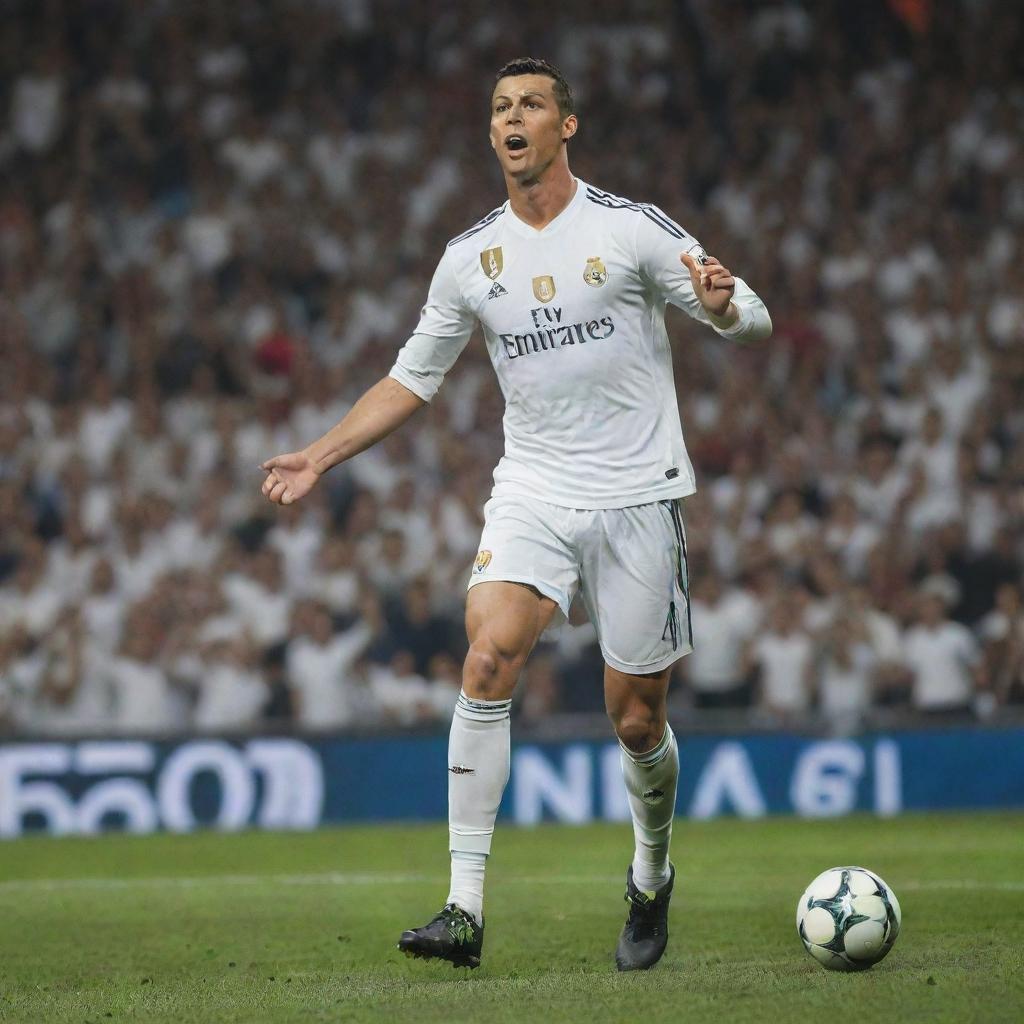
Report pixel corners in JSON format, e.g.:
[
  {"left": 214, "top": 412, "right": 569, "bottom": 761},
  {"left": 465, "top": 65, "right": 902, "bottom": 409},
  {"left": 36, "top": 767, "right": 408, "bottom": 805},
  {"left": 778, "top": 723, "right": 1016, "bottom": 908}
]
[{"left": 618, "top": 725, "right": 679, "bottom": 892}]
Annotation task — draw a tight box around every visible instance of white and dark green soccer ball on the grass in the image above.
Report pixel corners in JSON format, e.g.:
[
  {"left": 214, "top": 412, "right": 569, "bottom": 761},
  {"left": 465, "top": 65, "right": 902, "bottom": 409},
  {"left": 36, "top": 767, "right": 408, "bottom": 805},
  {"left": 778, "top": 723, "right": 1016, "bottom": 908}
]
[{"left": 797, "top": 867, "right": 900, "bottom": 971}]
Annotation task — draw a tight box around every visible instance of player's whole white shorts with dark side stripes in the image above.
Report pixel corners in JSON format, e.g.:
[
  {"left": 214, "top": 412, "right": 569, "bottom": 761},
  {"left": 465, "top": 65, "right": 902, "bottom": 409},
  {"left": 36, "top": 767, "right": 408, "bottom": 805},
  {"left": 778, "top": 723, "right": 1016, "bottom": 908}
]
[{"left": 469, "top": 496, "right": 693, "bottom": 675}]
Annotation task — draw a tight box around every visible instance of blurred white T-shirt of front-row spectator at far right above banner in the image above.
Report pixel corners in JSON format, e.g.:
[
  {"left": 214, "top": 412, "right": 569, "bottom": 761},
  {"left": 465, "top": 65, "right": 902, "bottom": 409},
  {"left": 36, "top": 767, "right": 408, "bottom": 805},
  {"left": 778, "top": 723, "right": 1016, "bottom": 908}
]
[{"left": 903, "top": 622, "right": 979, "bottom": 711}]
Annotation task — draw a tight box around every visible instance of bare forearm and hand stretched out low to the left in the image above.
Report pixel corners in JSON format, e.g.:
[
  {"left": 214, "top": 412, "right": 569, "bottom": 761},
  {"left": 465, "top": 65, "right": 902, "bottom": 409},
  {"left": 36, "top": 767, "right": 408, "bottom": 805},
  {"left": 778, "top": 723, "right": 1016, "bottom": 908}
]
[{"left": 260, "top": 377, "right": 426, "bottom": 505}]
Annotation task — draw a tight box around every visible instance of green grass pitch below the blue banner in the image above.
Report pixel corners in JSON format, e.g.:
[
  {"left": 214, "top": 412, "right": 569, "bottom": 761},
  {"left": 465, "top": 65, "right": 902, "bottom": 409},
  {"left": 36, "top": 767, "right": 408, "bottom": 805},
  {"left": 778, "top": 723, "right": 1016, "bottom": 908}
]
[{"left": 0, "top": 814, "right": 1024, "bottom": 1024}]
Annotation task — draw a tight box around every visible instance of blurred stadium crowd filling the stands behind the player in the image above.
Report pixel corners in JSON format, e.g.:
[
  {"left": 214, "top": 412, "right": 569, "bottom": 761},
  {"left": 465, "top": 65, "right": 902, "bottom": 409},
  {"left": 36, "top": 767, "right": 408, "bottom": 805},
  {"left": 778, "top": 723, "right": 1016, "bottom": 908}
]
[{"left": 0, "top": 0, "right": 1024, "bottom": 734}]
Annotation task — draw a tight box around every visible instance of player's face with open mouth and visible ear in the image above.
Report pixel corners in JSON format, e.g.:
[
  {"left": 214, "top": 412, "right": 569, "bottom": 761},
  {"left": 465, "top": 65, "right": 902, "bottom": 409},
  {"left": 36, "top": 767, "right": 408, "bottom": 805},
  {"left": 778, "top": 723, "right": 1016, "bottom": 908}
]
[{"left": 490, "top": 75, "right": 577, "bottom": 180}]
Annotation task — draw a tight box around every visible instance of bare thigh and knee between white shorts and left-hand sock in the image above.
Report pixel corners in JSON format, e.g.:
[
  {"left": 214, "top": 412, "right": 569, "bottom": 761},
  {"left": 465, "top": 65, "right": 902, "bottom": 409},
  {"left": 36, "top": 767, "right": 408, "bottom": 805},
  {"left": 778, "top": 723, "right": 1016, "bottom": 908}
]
[{"left": 463, "top": 581, "right": 558, "bottom": 700}]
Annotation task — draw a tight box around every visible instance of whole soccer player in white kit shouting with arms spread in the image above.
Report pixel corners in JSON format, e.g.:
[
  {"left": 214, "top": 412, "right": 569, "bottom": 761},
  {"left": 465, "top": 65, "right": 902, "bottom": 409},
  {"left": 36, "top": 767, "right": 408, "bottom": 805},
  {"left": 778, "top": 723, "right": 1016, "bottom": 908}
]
[{"left": 263, "top": 58, "right": 771, "bottom": 971}]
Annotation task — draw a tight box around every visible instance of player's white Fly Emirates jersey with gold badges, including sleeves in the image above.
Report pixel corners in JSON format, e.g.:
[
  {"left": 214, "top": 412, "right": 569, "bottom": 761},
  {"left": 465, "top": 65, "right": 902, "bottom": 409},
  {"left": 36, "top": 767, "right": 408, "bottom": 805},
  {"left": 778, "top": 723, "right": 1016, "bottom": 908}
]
[{"left": 391, "top": 180, "right": 771, "bottom": 509}]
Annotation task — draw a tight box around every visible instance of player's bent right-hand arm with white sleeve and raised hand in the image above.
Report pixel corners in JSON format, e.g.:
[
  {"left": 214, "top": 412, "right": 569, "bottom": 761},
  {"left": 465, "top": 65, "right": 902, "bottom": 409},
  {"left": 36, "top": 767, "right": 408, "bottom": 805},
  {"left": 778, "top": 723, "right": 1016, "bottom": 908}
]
[{"left": 636, "top": 207, "right": 772, "bottom": 341}]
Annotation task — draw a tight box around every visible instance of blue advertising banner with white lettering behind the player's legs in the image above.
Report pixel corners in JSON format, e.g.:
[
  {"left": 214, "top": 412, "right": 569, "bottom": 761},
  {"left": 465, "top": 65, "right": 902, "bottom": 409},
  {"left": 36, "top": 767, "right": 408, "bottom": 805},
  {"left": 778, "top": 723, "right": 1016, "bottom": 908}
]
[{"left": 0, "top": 729, "right": 1024, "bottom": 838}]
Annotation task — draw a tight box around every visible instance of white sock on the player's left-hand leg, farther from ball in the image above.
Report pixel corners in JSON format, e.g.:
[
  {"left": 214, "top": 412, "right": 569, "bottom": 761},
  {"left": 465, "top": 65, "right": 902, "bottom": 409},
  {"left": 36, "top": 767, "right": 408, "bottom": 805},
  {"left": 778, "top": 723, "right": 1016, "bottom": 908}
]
[{"left": 445, "top": 693, "right": 512, "bottom": 923}]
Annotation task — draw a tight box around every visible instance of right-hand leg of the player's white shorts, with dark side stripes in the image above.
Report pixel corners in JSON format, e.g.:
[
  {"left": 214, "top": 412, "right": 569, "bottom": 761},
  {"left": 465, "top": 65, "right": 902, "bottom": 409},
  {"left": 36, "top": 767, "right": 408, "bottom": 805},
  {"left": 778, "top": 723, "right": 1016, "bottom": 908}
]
[{"left": 582, "top": 502, "right": 693, "bottom": 677}]
